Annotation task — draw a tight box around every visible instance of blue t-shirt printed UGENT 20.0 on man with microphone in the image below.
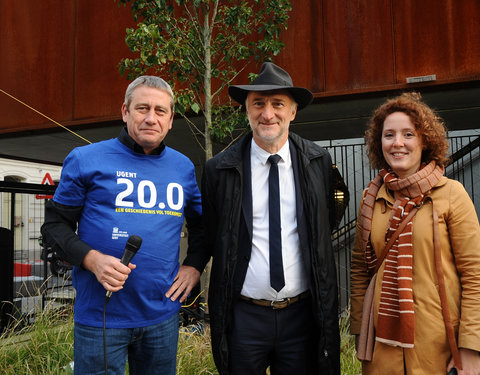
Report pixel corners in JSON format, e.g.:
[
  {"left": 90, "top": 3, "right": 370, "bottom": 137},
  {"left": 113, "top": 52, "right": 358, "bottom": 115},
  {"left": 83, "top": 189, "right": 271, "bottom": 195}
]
[{"left": 53, "top": 139, "right": 201, "bottom": 328}]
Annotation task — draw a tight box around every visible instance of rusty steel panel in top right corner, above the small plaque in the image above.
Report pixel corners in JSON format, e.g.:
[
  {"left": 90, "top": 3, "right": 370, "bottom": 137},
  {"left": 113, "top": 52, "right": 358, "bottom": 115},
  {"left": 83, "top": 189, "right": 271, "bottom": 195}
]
[{"left": 393, "top": 0, "right": 480, "bottom": 83}]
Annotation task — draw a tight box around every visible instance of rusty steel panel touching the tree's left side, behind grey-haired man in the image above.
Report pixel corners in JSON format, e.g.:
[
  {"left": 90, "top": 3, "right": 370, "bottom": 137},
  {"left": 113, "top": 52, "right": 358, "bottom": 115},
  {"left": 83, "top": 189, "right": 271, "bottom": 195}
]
[{"left": 73, "top": 0, "right": 134, "bottom": 121}]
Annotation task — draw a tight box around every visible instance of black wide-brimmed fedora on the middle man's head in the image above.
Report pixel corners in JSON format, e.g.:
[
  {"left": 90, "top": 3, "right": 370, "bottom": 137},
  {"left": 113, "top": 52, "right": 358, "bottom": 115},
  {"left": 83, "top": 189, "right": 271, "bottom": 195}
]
[{"left": 228, "top": 62, "right": 313, "bottom": 110}]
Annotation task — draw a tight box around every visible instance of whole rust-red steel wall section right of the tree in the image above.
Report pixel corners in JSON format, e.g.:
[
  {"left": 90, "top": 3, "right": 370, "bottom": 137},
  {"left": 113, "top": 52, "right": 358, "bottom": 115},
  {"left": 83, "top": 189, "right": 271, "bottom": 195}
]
[{"left": 276, "top": 0, "right": 480, "bottom": 96}]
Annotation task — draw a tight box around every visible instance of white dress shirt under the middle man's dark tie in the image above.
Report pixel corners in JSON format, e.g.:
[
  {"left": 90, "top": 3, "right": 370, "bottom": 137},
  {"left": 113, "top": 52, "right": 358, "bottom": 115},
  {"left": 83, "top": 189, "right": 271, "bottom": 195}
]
[{"left": 241, "top": 139, "right": 308, "bottom": 301}]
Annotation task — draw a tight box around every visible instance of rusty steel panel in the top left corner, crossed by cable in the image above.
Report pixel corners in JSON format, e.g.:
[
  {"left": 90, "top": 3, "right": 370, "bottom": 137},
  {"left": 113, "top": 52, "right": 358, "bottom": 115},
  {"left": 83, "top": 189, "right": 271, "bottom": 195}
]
[{"left": 0, "top": 0, "right": 74, "bottom": 133}]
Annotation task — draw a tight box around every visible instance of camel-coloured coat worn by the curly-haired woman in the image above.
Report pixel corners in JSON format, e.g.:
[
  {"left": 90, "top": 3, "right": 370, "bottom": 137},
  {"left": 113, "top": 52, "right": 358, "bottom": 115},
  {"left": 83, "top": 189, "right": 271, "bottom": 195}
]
[{"left": 351, "top": 177, "right": 480, "bottom": 375}]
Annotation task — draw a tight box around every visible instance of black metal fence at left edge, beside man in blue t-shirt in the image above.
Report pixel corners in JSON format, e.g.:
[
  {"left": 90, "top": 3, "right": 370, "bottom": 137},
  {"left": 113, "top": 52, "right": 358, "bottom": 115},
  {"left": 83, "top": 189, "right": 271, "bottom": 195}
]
[{"left": 0, "top": 181, "right": 74, "bottom": 332}]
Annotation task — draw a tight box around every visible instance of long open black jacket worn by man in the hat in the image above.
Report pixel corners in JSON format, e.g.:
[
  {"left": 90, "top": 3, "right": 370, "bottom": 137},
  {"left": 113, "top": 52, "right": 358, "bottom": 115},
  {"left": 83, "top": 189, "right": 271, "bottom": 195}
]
[{"left": 184, "top": 133, "right": 340, "bottom": 375}]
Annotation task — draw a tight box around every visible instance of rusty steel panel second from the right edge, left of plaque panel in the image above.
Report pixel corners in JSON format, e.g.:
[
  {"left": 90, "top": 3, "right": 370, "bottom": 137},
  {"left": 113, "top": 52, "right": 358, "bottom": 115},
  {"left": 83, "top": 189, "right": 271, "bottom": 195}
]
[{"left": 323, "top": 0, "right": 395, "bottom": 92}]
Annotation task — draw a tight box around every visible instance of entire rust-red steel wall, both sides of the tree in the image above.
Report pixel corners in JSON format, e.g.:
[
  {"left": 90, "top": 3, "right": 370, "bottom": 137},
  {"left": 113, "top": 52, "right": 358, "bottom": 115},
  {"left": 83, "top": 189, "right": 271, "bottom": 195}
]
[{"left": 0, "top": 0, "right": 480, "bottom": 134}]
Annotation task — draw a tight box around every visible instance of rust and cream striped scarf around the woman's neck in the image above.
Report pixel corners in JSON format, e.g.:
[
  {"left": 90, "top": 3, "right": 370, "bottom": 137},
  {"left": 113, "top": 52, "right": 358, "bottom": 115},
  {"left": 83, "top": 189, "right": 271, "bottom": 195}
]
[{"left": 359, "top": 161, "right": 444, "bottom": 348}]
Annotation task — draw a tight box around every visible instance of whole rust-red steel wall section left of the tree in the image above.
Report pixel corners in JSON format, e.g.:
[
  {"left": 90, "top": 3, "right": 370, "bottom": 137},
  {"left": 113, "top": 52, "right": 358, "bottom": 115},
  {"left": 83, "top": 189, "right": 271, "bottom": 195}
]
[{"left": 0, "top": 0, "right": 133, "bottom": 133}]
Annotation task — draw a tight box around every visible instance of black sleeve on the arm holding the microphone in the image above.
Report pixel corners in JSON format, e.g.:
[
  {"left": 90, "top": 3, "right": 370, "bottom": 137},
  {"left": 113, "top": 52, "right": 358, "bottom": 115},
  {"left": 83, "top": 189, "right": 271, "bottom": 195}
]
[{"left": 41, "top": 200, "right": 92, "bottom": 267}]
